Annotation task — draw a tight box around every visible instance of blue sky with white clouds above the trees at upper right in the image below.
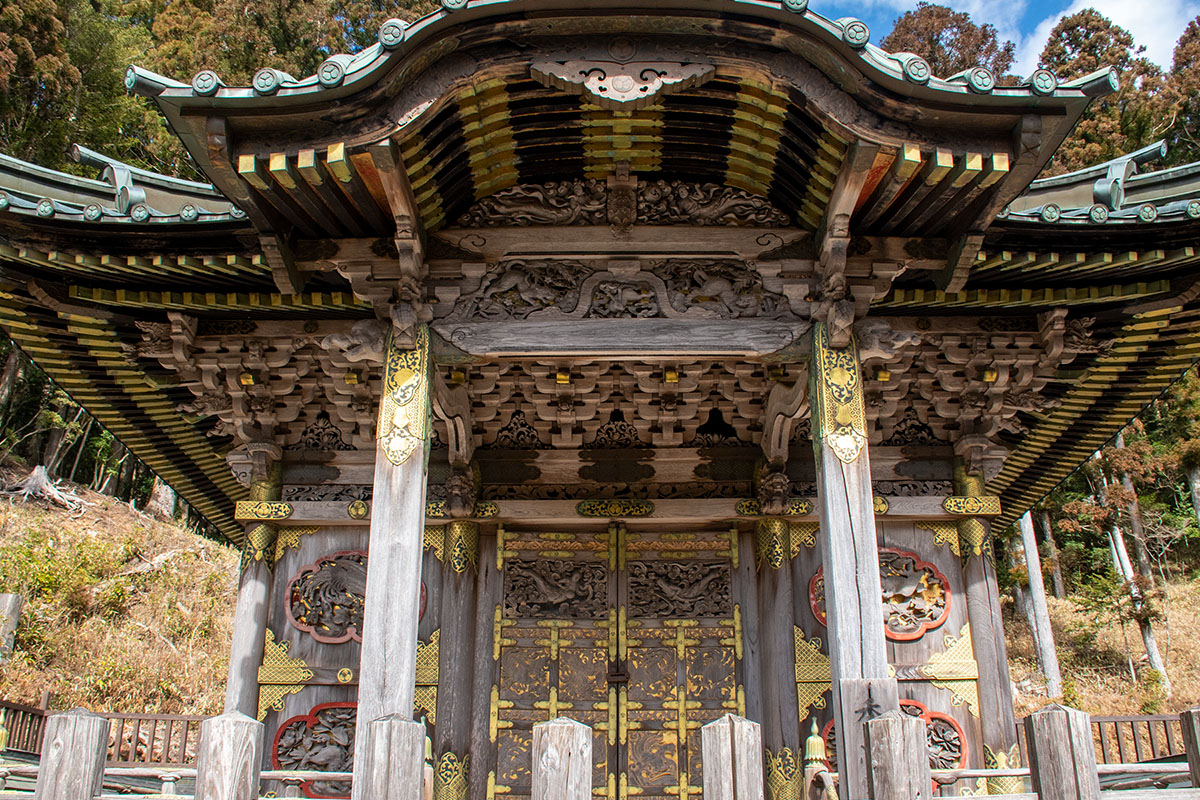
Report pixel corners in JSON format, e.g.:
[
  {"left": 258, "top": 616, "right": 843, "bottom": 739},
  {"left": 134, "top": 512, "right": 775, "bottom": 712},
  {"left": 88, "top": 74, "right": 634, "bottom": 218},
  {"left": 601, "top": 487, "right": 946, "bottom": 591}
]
[{"left": 809, "top": 0, "right": 1200, "bottom": 77}]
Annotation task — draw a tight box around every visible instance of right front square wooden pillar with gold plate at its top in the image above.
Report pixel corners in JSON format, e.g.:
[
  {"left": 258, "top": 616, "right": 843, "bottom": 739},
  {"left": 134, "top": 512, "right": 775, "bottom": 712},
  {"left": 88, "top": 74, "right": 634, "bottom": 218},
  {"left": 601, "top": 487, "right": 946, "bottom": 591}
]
[{"left": 809, "top": 323, "right": 900, "bottom": 798}]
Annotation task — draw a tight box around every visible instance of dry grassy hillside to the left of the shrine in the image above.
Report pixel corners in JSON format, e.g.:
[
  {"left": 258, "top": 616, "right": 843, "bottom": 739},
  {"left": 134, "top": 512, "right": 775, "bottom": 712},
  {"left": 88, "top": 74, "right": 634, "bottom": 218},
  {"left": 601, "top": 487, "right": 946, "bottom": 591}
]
[{"left": 0, "top": 479, "right": 236, "bottom": 714}]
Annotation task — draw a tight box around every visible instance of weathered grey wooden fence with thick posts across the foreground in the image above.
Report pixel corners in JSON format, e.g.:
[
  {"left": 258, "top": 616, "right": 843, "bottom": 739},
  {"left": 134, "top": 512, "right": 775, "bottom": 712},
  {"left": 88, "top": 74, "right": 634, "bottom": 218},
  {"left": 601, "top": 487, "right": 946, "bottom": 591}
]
[{"left": 0, "top": 705, "right": 1200, "bottom": 800}]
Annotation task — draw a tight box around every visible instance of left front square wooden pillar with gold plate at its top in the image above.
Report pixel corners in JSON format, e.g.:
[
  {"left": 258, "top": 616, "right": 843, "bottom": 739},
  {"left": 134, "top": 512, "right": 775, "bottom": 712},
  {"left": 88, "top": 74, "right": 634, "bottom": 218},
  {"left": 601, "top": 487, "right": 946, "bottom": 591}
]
[{"left": 354, "top": 325, "right": 430, "bottom": 800}]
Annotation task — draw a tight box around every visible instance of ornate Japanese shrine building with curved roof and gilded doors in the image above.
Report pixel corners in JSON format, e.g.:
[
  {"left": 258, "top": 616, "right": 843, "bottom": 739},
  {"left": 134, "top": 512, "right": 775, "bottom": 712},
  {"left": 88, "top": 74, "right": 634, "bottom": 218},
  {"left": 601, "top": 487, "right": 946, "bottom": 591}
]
[{"left": 0, "top": 0, "right": 1200, "bottom": 800}]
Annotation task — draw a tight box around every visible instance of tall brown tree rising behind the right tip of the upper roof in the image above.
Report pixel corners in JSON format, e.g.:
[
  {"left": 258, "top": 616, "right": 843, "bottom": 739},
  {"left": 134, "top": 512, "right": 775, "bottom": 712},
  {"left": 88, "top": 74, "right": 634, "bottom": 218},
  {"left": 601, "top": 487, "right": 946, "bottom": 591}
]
[{"left": 1039, "top": 8, "right": 1172, "bottom": 175}]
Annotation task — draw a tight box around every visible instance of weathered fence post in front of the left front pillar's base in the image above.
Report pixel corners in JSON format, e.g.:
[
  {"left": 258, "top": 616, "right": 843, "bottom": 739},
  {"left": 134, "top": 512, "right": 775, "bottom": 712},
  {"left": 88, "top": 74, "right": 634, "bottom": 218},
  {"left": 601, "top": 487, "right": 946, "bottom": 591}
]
[{"left": 353, "top": 714, "right": 425, "bottom": 800}]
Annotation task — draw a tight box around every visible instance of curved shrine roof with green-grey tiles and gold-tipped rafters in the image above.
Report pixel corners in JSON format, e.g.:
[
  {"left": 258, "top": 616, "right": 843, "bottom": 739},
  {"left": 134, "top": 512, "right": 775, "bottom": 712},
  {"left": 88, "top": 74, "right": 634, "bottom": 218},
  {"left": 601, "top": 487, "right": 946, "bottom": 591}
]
[{"left": 0, "top": 0, "right": 1200, "bottom": 537}]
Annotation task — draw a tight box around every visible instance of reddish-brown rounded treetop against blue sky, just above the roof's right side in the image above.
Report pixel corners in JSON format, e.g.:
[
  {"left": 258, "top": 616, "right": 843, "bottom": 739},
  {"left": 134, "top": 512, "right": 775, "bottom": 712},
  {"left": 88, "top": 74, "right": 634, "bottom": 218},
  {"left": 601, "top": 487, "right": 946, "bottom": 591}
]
[{"left": 880, "top": 1, "right": 1015, "bottom": 78}]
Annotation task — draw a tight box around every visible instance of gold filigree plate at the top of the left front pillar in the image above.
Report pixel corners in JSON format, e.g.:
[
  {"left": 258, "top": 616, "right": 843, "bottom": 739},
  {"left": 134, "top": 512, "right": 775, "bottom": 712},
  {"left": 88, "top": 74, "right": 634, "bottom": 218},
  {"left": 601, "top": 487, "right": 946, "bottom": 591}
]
[{"left": 377, "top": 325, "right": 430, "bottom": 467}]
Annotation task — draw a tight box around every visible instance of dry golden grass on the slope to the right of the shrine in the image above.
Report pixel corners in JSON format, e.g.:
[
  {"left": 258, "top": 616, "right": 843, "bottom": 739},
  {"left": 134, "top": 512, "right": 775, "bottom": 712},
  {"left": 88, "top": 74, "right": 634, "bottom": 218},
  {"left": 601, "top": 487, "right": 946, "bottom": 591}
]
[{"left": 1004, "top": 579, "right": 1200, "bottom": 716}]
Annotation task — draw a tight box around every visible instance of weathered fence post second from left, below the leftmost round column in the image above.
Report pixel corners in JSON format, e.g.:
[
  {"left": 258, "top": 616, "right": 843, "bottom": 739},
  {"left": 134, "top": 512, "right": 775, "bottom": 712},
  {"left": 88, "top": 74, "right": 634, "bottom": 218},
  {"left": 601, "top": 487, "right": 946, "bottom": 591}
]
[{"left": 196, "top": 711, "right": 263, "bottom": 800}]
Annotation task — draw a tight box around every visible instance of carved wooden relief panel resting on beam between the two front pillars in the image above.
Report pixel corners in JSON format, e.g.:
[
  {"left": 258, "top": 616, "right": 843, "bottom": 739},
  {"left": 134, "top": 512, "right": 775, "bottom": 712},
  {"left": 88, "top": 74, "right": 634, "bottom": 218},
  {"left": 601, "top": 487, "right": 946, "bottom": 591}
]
[{"left": 445, "top": 259, "right": 798, "bottom": 321}]
